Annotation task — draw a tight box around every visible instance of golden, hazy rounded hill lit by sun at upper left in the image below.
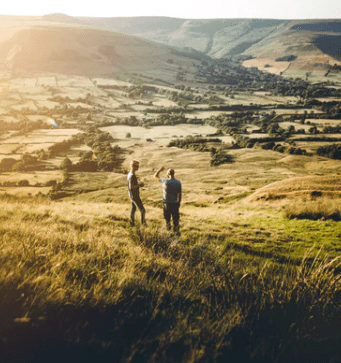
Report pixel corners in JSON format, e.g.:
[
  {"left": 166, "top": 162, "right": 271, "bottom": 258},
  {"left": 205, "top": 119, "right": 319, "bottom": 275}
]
[{"left": 0, "top": 17, "right": 202, "bottom": 76}]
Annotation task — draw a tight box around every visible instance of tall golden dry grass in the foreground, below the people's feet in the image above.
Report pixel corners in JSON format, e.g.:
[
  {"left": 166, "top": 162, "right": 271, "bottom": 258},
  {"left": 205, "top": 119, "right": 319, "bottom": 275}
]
[{"left": 0, "top": 200, "right": 341, "bottom": 362}]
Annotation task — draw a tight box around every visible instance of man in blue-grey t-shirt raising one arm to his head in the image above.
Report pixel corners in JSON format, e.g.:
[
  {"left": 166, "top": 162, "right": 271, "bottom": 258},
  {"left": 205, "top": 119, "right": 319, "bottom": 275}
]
[{"left": 154, "top": 166, "right": 182, "bottom": 235}]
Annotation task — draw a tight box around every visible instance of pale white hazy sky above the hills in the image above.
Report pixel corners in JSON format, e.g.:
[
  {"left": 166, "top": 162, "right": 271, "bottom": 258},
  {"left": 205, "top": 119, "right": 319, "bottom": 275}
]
[{"left": 0, "top": 0, "right": 341, "bottom": 19}]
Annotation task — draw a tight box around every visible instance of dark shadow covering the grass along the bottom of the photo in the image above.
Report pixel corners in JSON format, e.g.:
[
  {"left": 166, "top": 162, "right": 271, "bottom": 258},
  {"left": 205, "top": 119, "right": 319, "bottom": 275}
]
[{"left": 0, "top": 286, "right": 341, "bottom": 363}]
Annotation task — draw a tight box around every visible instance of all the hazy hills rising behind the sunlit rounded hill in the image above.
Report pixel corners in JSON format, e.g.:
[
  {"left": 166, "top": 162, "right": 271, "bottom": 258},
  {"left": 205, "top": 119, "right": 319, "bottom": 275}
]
[{"left": 41, "top": 14, "right": 341, "bottom": 65}]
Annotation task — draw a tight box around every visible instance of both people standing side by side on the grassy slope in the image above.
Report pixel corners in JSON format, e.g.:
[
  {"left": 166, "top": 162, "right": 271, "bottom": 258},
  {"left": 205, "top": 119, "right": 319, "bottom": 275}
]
[{"left": 127, "top": 160, "right": 182, "bottom": 235}]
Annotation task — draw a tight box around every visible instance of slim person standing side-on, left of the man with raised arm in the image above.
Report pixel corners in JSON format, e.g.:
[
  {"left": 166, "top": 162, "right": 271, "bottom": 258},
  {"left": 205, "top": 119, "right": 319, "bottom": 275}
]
[{"left": 127, "top": 160, "right": 146, "bottom": 226}]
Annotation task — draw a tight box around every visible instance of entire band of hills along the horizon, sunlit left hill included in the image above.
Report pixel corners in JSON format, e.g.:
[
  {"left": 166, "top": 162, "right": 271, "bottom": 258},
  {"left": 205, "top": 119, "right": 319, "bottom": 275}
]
[{"left": 0, "top": 14, "right": 341, "bottom": 74}]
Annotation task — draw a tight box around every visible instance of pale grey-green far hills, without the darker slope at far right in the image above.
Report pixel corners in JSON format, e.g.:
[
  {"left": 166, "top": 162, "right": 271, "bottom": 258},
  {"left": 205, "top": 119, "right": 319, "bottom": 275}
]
[{"left": 73, "top": 17, "right": 341, "bottom": 58}]
